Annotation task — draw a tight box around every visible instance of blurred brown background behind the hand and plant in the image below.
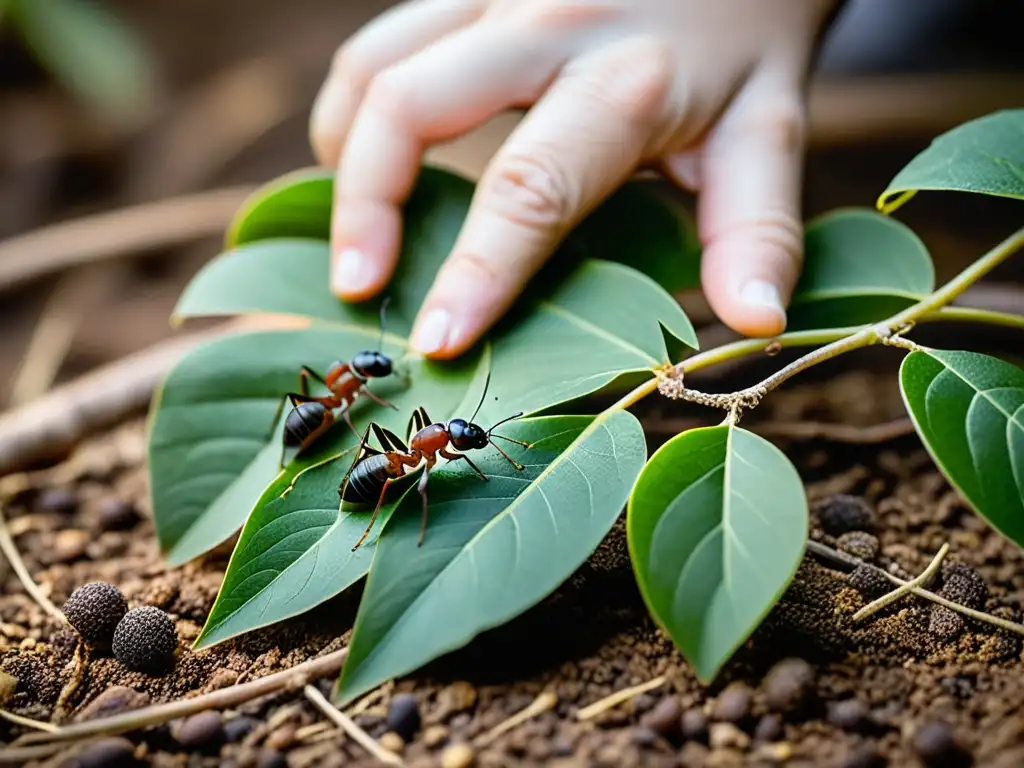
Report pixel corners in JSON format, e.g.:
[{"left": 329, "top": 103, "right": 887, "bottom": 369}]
[{"left": 0, "top": 0, "right": 1024, "bottom": 409}]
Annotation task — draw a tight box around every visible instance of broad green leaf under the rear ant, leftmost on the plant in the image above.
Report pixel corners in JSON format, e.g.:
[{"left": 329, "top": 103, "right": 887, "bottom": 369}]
[{"left": 150, "top": 327, "right": 479, "bottom": 565}]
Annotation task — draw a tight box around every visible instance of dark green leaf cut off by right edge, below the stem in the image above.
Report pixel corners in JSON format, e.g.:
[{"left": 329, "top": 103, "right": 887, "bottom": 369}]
[{"left": 900, "top": 349, "right": 1024, "bottom": 546}]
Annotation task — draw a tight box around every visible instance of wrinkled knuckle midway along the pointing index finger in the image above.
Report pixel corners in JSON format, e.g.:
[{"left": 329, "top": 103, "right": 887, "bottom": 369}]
[{"left": 484, "top": 156, "right": 575, "bottom": 229}]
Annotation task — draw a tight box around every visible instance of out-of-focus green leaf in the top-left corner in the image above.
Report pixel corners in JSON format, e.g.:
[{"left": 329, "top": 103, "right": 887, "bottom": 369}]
[{"left": 7, "top": 0, "right": 155, "bottom": 122}]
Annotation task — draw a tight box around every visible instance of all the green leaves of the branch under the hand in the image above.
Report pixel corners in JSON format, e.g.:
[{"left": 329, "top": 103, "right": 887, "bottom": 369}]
[{"left": 150, "top": 111, "right": 1024, "bottom": 700}]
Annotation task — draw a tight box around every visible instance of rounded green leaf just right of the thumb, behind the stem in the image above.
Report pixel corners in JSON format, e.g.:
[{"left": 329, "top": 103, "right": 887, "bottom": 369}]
[{"left": 786, "top": 208, "right": 935, "bottom": 331}]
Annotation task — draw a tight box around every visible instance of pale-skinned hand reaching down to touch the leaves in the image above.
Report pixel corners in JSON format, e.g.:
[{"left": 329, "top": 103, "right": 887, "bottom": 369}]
[{"left": 310, "top": 0, "right": 835, "bottom": 358}]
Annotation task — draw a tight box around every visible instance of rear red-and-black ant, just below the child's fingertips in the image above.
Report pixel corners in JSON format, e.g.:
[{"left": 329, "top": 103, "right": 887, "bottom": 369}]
[{"left": 270, "top": 299, "right": 398, "bottom": 469}]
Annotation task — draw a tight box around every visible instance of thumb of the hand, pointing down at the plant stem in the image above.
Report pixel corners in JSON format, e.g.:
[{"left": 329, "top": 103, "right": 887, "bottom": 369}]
[{"left": 698, "top": 74, "right": 805, "bottom": 337}]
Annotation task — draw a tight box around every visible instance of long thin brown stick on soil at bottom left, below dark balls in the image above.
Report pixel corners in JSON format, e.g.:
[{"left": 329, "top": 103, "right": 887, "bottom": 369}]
[{"left": 14, "top": 648, "right": 348, "bottom": 757}]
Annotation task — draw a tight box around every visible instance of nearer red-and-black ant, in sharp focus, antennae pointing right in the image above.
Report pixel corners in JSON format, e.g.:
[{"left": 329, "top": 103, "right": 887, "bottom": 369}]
[{"left": 338, "top": 373, "right": 530, "bottom": 552}]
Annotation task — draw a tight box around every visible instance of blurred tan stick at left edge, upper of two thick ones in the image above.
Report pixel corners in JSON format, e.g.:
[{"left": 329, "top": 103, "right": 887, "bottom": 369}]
[{"left": 0, "top": 186, "right": 253, "bottom": 291}]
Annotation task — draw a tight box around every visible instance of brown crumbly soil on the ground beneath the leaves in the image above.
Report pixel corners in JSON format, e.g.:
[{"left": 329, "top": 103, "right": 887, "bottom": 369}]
[{"left": 0, "top": 362, "right": 1024, "bottom": 768}]
